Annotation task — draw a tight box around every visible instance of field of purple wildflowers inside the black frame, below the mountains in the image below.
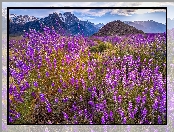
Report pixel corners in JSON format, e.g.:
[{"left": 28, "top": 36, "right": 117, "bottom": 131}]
[{"left": 8, "top": 28, "right": 167, "bottom": 124}]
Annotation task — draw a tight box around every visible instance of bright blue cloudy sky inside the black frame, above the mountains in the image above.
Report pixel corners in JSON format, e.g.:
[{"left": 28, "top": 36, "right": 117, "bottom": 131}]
[{"left": 10, "top": 9, "right": 166, "bottom": 24}]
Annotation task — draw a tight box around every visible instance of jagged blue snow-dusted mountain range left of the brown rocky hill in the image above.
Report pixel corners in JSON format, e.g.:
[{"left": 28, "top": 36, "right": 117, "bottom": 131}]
[{"left": 9, "top": 12, "right": 104, "bottom": 36}]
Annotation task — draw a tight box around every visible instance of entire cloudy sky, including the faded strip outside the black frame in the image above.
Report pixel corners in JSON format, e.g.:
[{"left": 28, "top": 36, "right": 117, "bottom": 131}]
[{"left": 2, "top": 2, "right": 174, "bottom": 24}]
